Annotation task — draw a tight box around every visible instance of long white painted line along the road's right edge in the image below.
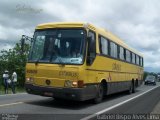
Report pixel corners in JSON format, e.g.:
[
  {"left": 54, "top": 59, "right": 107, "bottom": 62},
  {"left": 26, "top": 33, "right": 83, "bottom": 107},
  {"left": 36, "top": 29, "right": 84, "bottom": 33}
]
[{"left": 80, "top": 85, "right": 159, "bottom": 120}]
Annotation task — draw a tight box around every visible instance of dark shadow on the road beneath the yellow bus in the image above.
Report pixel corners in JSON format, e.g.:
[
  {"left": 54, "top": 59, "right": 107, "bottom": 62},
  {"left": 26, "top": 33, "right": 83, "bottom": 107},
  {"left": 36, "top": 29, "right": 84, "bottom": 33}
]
[{"left": 25, "top": 90, "right": 138, "bottom": 110}]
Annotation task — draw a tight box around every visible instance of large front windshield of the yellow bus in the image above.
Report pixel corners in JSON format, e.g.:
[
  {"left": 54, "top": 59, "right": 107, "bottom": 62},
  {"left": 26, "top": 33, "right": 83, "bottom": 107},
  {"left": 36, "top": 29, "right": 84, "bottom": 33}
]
[{"left": 28, "top": 29, "right": 86, "bottom": 64}]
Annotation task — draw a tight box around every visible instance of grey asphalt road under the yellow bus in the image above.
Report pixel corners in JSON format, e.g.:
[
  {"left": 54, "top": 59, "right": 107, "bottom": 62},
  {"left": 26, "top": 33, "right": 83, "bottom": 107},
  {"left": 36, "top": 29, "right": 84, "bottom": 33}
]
[{"left": 0, "top": 83, "right": 160, "bottom": 120}]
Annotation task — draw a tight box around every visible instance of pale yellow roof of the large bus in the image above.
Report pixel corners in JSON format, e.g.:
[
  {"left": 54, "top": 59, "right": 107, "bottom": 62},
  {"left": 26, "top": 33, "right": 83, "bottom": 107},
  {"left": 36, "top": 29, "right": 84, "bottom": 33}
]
[{"left": 36, "top": 22, "right": 143, "bottom": 57}]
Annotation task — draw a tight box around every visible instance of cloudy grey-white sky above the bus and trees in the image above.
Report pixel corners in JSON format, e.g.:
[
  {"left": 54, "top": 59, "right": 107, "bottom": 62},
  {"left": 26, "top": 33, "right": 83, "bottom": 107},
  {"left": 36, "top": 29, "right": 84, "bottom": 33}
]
[{"left": 0, "top": 0, "right": 160, "bottom": 72}]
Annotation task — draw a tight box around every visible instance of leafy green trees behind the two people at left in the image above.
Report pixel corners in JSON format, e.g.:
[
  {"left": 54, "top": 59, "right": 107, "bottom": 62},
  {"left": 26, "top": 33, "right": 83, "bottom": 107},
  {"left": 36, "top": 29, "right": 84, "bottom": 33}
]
[{"left": 0, "top": 43, "right": 29, "bottom": 87}]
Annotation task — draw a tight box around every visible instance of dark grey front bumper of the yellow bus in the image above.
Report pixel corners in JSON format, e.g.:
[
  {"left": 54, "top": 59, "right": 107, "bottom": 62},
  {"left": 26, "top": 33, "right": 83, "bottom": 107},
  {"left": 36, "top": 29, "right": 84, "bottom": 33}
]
[{"left": 25, "top": 83, "right": 97, "bottom": 101}]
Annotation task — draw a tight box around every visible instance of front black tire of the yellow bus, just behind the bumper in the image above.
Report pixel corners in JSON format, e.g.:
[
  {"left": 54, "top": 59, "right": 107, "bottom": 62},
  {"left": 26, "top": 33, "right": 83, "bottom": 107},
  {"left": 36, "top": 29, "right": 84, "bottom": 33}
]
[{"left": 94, "top": 84, "right": 104, "bottom": 104}]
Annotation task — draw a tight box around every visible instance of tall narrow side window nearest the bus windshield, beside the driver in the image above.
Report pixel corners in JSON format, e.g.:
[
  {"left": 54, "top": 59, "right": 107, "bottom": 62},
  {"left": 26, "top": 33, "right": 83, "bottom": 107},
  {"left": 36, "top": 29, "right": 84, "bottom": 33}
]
[{"left": 87, "top": 31, "right": 96, "bottom": 65}]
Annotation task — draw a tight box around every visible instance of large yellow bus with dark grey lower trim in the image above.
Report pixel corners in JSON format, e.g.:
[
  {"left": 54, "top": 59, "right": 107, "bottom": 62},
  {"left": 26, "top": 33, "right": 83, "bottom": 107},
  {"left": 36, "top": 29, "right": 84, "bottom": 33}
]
[{"left": 25, "top": 22, "right": 143, "bottom": 103}]
